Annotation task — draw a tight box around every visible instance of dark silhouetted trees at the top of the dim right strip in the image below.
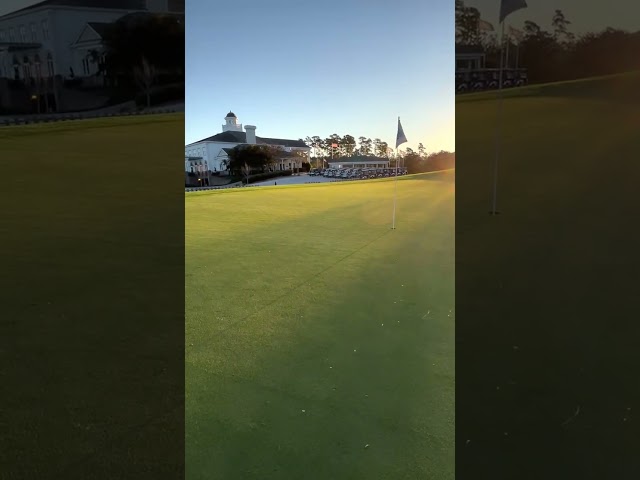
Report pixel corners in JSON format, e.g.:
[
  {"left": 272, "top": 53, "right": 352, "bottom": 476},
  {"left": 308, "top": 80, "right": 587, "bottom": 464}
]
[{"left": 456, "top": 0, "right": 640, "bottom": 83}]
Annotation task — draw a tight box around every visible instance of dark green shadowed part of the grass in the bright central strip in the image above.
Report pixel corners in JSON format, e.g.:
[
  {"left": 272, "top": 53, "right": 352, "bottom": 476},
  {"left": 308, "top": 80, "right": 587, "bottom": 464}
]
[{"left": 187, "top": 219, "right": 454, "bottom": 479}]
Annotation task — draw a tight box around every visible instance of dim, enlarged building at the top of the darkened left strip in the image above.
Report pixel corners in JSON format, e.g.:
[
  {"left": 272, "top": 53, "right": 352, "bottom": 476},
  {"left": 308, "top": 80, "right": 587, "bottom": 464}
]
[{"left": 0, "top": 0, "right": 185, "bottom": 113}]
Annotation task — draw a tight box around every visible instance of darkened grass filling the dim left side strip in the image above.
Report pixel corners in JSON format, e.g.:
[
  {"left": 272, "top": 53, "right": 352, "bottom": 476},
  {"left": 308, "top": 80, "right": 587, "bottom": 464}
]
[{"left": 0, "top": 115, "right": 184, "bottom": 479}]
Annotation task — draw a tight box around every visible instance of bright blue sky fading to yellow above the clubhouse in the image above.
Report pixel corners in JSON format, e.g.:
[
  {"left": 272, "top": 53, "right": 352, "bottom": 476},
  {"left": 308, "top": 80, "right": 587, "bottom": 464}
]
[{"left": 185, "top": 0, "right": 455, "bottom": 151}]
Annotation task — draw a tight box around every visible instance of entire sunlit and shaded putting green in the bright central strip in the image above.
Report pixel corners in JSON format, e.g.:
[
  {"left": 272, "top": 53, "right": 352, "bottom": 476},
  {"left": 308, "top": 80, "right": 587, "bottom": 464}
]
[{"left": 185, "top": 172, "right": 455, "bottom": 480}]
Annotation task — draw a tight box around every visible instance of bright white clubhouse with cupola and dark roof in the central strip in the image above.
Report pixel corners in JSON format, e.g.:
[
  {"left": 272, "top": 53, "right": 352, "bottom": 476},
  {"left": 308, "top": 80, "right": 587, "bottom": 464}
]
[{"left": 185, "top": 112, "right": 311, "bottom": 173}]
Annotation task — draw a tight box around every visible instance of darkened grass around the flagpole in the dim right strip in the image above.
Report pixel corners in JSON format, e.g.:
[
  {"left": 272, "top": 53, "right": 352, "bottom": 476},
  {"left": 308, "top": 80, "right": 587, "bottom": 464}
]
[{"left": 456, "top": 74, "right": 640, "bottom": 478}]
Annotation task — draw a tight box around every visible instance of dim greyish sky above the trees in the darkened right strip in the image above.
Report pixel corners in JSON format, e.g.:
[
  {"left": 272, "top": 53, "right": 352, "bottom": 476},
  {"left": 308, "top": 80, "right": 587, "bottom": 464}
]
[{"left": 462, "top": 0, "right": 640, "bottom": 34}]
